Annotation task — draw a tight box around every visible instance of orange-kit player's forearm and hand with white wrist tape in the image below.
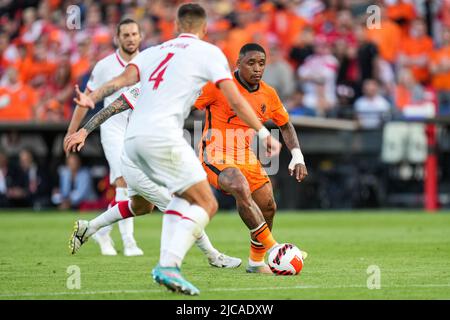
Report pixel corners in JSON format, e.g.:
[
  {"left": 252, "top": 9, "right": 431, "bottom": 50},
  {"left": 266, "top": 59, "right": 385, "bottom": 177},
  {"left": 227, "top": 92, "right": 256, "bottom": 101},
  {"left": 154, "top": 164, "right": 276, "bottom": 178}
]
[{"left": 280, "top": 122, "right": 308, "bottom": 182}]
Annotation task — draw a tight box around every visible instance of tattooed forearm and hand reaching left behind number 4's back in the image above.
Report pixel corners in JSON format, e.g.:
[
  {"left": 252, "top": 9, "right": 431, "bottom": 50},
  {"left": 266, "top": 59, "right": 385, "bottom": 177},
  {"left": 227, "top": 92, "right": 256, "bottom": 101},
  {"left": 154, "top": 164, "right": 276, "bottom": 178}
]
[{"left": 66, "top": 96, "right": 131, "bottom": 154}]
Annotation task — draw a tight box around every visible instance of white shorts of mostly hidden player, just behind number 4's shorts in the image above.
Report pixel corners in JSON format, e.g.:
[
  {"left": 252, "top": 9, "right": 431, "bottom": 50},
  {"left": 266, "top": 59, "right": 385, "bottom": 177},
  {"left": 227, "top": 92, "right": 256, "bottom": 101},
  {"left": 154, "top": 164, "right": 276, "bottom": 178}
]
[{"left": 121, "top": 152, "right": 172, "bottom": 212}]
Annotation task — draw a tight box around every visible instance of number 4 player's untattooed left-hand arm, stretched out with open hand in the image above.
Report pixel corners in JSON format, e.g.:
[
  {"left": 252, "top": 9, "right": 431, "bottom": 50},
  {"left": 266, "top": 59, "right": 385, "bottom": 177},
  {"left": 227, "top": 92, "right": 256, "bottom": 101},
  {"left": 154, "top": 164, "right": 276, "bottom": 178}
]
[{"left": 73, "top": 65, "right": 139, "bottom": 109}]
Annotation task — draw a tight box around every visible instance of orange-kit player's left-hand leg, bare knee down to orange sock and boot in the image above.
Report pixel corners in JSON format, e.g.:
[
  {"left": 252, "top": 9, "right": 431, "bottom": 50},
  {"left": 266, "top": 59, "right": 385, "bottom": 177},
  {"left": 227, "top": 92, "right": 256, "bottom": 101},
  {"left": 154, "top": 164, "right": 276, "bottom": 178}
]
[{"left": 218, "top": 167, "right": 277, "bottom": 273}]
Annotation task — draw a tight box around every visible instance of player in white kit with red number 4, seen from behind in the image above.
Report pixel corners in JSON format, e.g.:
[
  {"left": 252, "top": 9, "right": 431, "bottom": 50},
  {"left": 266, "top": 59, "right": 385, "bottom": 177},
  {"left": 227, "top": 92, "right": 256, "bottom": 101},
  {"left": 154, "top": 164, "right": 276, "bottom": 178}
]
[{"left": 71, "top": 3, "right": 281, "bottom": 295}]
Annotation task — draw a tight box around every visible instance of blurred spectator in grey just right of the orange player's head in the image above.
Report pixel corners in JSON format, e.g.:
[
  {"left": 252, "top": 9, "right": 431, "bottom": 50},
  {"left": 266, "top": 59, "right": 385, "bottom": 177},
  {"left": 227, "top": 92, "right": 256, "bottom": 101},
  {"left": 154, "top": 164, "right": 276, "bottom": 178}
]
[{"left": 263, "top": 46, "right": 295, "bottom": 101}]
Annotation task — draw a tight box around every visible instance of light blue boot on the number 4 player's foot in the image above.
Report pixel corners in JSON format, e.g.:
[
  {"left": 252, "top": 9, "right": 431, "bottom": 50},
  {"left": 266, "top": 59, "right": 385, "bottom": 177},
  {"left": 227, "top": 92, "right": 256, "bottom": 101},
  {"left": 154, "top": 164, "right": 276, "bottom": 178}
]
[{"left": 152, "top": 264, "right": 200, "bottom": 296}]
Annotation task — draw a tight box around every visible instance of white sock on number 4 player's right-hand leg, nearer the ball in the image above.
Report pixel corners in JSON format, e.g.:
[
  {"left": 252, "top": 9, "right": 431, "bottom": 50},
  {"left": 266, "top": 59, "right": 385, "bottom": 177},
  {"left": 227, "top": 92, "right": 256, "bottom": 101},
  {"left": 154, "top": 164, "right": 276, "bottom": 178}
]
[{"left": 160, "top": 205, "right": 209, "bottom": 268}]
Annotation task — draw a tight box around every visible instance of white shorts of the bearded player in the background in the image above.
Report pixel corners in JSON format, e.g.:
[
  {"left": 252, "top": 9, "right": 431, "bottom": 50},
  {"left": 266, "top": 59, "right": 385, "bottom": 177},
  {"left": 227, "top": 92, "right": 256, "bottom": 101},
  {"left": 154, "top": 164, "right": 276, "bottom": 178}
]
[{"left": 100, "top": 127, "right": 125, "bottom": 184}]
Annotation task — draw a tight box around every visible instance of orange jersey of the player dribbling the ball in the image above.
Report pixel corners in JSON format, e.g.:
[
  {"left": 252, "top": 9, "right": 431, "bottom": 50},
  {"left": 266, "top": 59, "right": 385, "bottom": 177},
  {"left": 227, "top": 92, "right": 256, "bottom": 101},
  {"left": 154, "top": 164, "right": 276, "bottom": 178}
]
[{"left": 194, "top": 72, "right": 289, "bottom": 164}]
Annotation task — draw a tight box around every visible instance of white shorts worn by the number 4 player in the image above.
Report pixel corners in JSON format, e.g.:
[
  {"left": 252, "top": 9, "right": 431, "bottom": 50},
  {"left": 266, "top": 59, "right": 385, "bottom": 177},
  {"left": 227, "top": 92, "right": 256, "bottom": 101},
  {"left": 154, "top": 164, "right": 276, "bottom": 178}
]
[{"left": 125, "top": 136, "right": 206, "bottom": 194}]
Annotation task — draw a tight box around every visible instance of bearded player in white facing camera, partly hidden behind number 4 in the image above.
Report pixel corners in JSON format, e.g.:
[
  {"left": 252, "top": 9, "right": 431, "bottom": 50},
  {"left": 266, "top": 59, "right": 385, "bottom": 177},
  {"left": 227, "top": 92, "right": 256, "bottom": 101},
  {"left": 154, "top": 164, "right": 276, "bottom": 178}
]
[{"left": 64, "top": 19, "right": 144, "bottom": 256}]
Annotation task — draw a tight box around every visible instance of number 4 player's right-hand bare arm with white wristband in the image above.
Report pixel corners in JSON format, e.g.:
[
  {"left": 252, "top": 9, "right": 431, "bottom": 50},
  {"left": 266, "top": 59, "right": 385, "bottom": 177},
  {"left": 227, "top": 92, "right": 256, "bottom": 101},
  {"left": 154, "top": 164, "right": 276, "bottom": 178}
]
[{"left": 219, "top": 80, "right": 281, "bottom": 156}]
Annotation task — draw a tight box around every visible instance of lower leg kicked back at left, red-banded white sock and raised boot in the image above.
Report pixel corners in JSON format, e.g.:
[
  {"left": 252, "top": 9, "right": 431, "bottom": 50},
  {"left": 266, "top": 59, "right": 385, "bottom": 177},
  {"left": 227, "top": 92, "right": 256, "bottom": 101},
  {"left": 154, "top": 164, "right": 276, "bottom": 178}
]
[{"left": 69, "top": 195, "right": 154, "bottom": 254}]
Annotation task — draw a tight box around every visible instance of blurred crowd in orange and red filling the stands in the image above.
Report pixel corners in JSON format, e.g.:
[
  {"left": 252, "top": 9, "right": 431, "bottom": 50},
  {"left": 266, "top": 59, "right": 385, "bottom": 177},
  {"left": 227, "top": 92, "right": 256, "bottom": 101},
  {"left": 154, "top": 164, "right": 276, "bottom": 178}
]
[{"left": 0, "top": 0, "right": 450, "bottom": 127}]
